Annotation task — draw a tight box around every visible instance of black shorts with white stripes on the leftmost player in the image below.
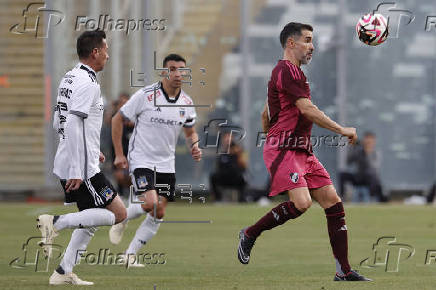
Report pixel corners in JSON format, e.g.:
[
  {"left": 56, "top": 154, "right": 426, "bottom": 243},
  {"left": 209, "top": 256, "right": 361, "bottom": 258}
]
[{"left": 60, "top": 172, "right": 118, "bottom": 211}]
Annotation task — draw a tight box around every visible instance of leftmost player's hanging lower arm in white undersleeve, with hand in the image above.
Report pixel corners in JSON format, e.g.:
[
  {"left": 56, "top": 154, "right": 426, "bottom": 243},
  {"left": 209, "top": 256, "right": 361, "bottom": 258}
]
[{"left": 65, "top": 113, "right": 83, "bottom": 192}]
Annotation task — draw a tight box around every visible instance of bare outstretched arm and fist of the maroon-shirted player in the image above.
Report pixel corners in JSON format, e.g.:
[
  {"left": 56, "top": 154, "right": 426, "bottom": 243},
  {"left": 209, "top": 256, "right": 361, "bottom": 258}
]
[{"left": 295, "top": 98, "right": 357, "bottom": 144}]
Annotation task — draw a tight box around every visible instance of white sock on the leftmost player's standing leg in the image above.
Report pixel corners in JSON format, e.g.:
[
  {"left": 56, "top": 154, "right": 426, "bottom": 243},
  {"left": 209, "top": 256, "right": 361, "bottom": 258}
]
[{"left": 60, "top": 228, "right": 97, "bottom": 273}]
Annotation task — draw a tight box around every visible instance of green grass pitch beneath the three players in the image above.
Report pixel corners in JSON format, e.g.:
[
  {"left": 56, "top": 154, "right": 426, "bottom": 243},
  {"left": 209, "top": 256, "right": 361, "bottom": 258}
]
[{"left": 0, "top": 203, "right": 436, "bottom": 290}]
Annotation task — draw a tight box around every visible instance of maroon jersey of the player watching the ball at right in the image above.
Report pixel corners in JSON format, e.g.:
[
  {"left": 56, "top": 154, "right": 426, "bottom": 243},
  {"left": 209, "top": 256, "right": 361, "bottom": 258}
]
[{"left": 267, "top": 60, "right": 313, "bottom": 154}]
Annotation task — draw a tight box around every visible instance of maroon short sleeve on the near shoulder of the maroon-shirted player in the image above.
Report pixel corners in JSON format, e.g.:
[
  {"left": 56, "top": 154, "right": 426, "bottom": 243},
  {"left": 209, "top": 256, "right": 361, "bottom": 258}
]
[{"left": 278, "top": 65, "right": 310, "bottom": 103}]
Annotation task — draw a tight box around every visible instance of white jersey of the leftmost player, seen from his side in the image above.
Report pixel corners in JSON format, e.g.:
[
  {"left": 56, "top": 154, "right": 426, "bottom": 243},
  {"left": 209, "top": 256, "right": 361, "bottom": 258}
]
[{"left": 53, "top": 62, "right": 104, "bottom": 180}]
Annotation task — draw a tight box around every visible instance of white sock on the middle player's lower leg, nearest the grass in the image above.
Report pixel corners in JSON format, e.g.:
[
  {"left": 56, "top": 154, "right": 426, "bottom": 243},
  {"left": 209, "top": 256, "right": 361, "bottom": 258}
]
[{"left": 126, "top": 214, "right": 162, "bottom": 255}]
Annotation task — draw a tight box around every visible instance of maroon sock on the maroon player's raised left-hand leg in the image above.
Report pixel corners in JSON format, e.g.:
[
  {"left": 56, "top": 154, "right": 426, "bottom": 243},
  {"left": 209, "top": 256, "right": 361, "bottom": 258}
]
[{"left": 245, "top": 201, "right": 302, "bottom": 239}]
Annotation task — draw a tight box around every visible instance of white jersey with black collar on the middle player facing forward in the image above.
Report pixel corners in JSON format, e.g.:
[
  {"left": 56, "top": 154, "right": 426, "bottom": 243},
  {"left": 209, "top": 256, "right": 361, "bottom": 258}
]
[{"left": 120, "top": 82, "right": 196, "bottom": 173}]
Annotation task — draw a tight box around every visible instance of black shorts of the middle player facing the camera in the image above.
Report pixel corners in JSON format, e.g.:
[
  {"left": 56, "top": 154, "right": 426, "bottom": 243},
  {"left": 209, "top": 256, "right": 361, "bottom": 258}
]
[{"left": 131, "top": 168, "right": 176, "bottom": 201}]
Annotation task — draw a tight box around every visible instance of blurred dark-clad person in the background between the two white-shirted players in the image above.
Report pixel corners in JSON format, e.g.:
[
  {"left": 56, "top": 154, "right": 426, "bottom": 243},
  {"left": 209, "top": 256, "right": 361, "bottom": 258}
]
[{"left": 110, "top": 93, "right": 135, "bottom": 195}]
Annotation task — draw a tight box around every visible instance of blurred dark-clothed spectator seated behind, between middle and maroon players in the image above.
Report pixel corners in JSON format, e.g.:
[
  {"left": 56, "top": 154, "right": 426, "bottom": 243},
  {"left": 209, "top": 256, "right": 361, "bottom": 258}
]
[{"left": 210, "top": 132, "right": 247, "bottom": 202}]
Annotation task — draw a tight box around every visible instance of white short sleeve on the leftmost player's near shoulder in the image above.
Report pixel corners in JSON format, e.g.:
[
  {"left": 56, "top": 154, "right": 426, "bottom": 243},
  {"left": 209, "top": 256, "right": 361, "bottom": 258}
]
[{"left": 69, "top": 83, "right": 98, "bottom": 118}]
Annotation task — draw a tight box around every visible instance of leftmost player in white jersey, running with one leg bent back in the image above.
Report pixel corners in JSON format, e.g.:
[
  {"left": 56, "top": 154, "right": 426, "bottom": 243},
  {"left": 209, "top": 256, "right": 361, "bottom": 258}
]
[{"left": 37, "top": 30, "right": 127, "bottom": 285}]
